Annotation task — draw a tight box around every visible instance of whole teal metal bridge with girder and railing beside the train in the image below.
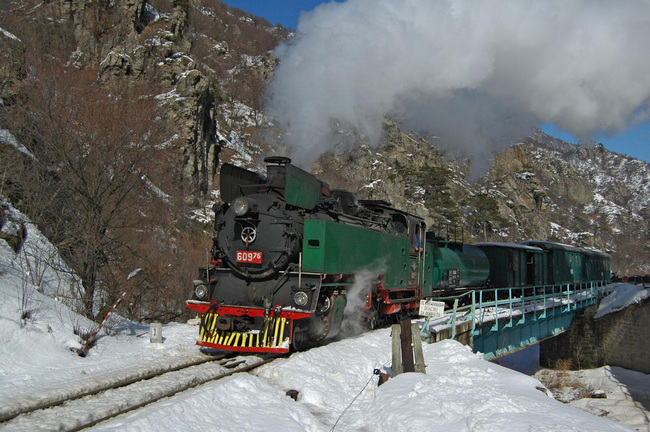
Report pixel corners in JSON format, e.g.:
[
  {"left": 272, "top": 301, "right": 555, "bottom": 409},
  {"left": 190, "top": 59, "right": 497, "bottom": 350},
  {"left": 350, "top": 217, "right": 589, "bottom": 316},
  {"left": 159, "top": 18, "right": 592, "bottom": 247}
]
[{"left": 421, "top": 282, "right": 607, "bottom": 360}]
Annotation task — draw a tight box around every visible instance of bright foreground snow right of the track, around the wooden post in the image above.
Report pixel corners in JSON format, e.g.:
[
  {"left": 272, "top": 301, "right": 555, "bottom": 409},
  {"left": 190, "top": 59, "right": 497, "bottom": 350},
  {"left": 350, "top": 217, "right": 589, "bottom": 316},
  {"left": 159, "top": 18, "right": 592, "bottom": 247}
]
[{"left": 86, "top": 338, "right": 630, "bottom": 431}]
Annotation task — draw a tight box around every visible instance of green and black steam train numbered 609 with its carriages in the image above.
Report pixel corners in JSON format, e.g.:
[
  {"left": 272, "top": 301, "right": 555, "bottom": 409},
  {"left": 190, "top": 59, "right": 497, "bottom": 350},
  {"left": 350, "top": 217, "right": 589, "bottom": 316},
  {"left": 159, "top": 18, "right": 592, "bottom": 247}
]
[{"left": 186, "top": 156, "right": 610, "bottom": 353}]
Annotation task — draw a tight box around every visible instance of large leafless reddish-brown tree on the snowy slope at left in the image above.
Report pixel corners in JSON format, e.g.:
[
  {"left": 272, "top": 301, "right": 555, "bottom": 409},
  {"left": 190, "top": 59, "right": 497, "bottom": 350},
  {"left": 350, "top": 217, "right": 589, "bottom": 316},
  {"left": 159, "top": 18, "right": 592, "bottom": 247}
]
[{"left": 3, "top": 65, "right": 180, "bottom": 317}]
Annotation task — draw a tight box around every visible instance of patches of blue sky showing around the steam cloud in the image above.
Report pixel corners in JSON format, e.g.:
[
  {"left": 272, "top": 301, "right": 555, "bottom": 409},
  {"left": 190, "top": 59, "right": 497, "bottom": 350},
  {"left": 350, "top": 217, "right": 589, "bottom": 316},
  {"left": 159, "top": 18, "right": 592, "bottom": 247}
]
[{"left": 220, "top": 0, "right": 650, "bottom": 162}]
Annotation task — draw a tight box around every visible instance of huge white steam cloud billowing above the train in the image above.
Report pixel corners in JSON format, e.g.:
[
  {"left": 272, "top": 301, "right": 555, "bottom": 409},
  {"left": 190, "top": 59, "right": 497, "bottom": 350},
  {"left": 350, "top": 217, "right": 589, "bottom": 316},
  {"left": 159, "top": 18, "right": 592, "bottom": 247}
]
[{"left": 266, "top": 0, "right": 650, "bottom": 168}]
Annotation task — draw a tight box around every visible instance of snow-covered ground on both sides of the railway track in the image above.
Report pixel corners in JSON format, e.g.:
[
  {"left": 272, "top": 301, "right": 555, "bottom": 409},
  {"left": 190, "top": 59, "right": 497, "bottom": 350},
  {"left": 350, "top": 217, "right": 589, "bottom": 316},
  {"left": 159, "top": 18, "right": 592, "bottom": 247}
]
[{"left": 0, "top": 197, "right": 647, "bottom": 432}]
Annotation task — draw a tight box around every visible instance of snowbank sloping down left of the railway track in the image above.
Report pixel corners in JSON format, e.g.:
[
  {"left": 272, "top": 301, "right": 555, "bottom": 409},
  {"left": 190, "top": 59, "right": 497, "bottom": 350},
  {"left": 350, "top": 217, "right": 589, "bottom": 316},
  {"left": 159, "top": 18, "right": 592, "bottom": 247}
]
[{"left": 0, "top": 197, "right": 204, "bottom": 411}]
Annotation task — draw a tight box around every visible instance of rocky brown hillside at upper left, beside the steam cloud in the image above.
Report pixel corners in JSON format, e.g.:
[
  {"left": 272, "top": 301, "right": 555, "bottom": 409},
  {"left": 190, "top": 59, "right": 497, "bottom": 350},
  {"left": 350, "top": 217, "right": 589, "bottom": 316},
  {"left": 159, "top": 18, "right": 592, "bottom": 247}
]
[{"left": 0, "top": 0, "right": 288, "bottom": 201}]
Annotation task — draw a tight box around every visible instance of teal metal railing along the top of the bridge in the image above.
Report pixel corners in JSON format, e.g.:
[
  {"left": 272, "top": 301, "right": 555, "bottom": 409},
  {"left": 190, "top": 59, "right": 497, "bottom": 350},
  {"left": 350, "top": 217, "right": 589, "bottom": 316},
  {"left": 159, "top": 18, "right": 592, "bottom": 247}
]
[{"left": 421, "top": 281, "right": 607, "bottom": 339}]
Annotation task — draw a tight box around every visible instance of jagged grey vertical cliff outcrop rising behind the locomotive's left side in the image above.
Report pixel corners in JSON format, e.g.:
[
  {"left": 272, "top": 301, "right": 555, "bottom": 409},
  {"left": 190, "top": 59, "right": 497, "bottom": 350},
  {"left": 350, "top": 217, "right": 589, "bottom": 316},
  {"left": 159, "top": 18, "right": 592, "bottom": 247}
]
[{"left": 87, "top": 0, "right": 219, "bottom": 196}]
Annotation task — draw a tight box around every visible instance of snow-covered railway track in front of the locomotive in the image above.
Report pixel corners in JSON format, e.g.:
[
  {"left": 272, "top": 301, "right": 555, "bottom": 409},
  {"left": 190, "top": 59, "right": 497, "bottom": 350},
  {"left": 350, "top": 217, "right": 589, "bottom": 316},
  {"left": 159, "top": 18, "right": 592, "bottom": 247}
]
[{"left": 0, "top": 355, "right": 275, "bottom": 432}]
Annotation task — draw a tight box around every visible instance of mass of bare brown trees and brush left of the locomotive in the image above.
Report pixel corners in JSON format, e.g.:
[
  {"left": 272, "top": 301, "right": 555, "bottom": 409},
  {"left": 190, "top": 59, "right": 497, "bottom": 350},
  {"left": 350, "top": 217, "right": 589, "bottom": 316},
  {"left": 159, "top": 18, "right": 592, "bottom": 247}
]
[{"left": 0, "top": 0, "right": 220, "bottom": 319}]
